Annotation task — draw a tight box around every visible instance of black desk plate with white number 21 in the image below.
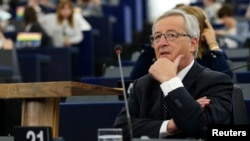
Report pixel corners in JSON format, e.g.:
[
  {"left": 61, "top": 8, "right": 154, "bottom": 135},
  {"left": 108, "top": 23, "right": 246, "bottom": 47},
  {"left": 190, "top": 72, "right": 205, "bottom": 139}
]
[{"left": 14, "top": 126, "right": 52, "bottom": 141}]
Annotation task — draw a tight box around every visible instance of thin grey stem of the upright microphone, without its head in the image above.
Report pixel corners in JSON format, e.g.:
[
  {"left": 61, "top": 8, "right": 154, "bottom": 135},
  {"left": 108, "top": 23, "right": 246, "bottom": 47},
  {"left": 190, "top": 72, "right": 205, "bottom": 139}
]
[{"left": 117, "top": 53, "right": 133, "bottom": 141}]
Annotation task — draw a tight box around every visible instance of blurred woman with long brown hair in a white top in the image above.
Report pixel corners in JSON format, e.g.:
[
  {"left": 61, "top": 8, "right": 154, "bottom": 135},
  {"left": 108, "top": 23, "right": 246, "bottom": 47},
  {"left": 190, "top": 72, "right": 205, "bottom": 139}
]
[{"left": 40, "top": 1, "right": 91, "bottom": 47}]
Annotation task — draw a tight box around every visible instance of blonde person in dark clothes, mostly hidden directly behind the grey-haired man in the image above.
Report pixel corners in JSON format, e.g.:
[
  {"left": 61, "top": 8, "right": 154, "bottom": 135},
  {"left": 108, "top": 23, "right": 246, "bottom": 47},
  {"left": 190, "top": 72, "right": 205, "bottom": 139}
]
[{"left": 130, "top": 6, "right": 233, "bottom": 80}]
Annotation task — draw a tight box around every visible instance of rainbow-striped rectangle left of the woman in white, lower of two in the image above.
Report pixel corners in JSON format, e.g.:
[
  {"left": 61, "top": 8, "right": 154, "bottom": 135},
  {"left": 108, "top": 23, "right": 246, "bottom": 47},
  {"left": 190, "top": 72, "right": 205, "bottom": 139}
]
[{"left": 16, "top": 32, "right": 42, "bottom": 48}]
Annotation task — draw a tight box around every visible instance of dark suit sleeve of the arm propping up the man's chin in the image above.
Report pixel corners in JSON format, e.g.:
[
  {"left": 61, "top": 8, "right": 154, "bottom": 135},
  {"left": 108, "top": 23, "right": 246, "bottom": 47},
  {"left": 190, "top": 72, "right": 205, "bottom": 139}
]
[{"left": 164, "top": 73, "right": 233, "bottom": 136}]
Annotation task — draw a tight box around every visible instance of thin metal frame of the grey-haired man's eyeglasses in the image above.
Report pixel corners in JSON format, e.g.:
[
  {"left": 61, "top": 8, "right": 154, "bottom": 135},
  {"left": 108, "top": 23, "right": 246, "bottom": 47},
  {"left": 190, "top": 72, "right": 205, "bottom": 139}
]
[{"left": 149, "top": 31, "right": 192, "bottom": 44}]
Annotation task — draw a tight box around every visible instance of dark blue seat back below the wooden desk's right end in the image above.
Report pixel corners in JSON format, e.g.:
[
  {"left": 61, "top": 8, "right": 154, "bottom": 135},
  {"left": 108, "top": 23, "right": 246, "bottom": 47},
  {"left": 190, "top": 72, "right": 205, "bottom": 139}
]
[{"left": 59, "top": 102, "right": 124, "bottom": 141}]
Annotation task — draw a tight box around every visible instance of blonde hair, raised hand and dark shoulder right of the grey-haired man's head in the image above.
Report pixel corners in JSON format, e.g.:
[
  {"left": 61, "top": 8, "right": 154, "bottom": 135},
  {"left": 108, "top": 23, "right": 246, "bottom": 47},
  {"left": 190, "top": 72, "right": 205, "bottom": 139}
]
[{"left": 180, "top": 6, "right": 233, "bottom": 78}]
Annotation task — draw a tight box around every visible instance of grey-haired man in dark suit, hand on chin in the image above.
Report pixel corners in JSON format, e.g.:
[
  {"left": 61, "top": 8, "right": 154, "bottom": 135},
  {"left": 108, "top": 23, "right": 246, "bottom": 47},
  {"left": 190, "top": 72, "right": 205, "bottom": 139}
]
[{"left": 114, "top": 9, "right": 233, "bottom": 141}]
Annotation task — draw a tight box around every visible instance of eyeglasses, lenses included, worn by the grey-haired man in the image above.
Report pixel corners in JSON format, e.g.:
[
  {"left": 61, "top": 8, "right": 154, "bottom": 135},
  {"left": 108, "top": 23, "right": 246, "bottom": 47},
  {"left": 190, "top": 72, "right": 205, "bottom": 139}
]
[{"left": 150, "top": 31, "right": 192, "bottom": 44}]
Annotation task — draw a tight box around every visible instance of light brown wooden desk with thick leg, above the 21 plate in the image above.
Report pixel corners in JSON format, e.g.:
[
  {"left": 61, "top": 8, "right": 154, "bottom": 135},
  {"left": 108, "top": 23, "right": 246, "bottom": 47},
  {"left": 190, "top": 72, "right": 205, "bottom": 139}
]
[{"left": 0, "top": 81, "right": 122, "bottom": 137}]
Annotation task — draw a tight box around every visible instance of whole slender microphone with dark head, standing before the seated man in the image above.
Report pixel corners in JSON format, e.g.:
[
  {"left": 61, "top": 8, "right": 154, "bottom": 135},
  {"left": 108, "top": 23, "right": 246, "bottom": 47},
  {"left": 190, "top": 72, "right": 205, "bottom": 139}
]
[{"left": 114, "top": 45, "right": 133, "bottom": 141}]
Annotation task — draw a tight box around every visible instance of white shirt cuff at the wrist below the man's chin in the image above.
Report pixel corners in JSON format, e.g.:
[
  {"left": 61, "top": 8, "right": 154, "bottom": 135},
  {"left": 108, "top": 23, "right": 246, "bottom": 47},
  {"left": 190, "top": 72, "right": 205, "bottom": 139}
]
[{"left": 160, "top": 77, "right": 184, "bottom": 96}]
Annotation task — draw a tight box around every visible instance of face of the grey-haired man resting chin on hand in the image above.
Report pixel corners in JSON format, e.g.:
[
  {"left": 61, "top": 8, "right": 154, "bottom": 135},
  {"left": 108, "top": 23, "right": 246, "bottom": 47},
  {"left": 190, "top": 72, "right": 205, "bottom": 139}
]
[{"left": 152, "top": 16, "right": 198, "bottom": 64}]
